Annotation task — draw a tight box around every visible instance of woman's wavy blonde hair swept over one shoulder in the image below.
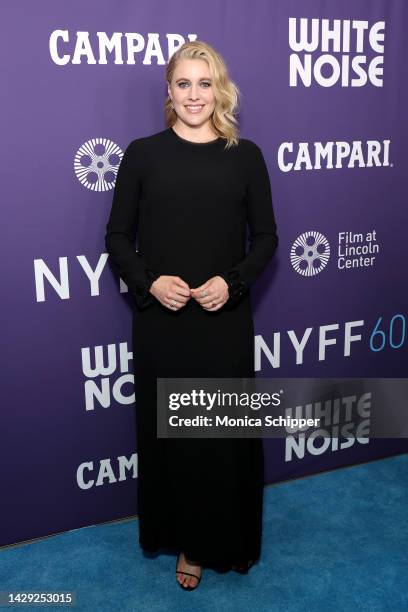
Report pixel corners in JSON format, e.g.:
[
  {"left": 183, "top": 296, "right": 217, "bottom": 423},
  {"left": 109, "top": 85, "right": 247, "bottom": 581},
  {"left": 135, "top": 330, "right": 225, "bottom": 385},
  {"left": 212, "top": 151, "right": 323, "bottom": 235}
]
[{"left": 164, "top": 40, "right": 240, "bottom": 149}]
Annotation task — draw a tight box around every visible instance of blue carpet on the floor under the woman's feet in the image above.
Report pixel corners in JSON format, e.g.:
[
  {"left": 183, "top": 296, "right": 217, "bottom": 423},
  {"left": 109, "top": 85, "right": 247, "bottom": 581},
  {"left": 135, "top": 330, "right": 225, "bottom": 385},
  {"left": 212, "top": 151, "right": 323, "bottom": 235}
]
[{"left": 0, "top": 455, "right": 408, "bottom": 612}]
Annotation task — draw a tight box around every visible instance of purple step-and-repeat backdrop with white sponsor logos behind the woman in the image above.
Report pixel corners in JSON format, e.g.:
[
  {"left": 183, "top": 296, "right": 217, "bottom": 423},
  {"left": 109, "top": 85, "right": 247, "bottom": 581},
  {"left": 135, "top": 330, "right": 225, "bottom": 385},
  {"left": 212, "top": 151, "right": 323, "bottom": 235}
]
[{"left": 0, "top": 0, "right": 408, "bottom": 545}]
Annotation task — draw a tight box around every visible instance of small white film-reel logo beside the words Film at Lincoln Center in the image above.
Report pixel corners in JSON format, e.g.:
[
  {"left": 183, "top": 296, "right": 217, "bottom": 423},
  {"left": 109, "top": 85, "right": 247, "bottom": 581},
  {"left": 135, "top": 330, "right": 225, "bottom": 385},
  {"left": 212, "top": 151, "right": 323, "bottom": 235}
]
[{"left": 290, "top": 231, "right": 330, "bottom": 276}]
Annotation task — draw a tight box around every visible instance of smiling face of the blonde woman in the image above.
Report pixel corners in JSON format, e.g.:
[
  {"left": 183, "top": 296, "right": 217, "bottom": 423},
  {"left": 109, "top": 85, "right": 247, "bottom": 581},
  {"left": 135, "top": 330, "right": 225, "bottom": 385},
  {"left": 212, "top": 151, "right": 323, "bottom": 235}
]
[{"left": 168, "top": 59, "right": 215, "bottom": 127}]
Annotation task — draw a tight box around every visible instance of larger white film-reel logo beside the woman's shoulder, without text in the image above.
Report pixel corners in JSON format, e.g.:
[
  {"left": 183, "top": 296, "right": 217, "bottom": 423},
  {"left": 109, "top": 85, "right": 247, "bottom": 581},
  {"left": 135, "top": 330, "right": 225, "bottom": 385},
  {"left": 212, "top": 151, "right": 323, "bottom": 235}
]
[{"left": 74, "top": 138, "right": 123, "bottom": 191}]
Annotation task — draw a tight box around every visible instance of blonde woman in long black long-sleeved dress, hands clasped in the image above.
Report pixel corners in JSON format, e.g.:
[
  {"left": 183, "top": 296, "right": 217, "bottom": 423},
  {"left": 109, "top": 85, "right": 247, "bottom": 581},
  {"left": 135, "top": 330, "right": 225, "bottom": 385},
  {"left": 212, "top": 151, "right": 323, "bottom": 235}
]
[{"left": 106, "top": 41, "right": 278, "bottom": 590}]
